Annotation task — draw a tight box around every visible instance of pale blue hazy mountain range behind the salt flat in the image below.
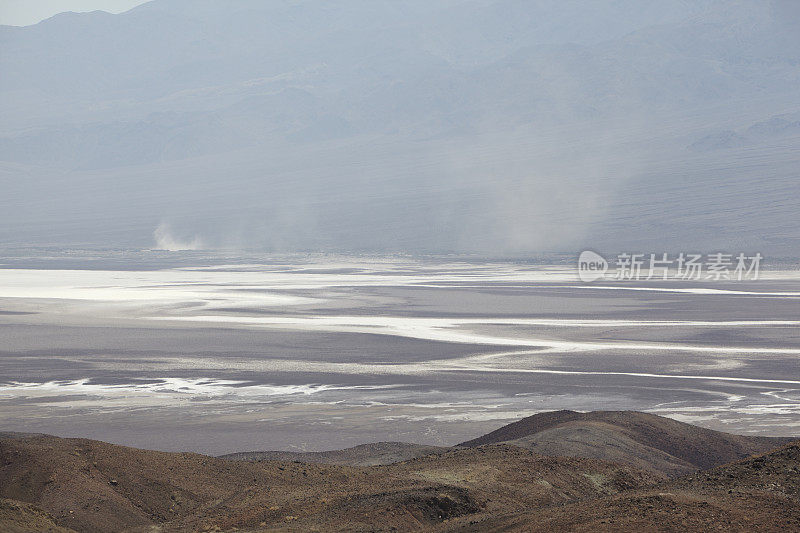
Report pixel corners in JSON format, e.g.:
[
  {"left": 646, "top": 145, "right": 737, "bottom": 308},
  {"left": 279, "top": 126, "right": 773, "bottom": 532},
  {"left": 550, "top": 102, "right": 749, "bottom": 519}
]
[{"left": 0, "top": 0, "right": 800, "bottom": 254}]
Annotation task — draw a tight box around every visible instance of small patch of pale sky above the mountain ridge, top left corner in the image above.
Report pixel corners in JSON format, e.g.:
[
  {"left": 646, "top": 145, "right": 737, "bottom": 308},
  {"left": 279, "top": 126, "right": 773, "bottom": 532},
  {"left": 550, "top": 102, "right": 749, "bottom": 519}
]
[{"left": 0, "top": 0, "right": 147, "bottom": 26}]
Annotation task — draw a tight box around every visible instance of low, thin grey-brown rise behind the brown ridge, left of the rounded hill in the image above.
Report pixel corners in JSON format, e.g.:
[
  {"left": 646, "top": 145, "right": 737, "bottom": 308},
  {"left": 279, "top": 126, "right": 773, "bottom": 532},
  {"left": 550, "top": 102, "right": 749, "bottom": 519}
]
[{"left": 220, "top": 442, "right": 450, "bottom": 466}]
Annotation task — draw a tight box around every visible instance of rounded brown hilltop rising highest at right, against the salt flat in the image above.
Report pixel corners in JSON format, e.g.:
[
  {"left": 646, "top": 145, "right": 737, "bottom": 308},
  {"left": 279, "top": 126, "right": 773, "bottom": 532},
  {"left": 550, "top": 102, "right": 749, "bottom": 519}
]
[{"left": 460, "top": 411, "right": 791, "bottom": 477}]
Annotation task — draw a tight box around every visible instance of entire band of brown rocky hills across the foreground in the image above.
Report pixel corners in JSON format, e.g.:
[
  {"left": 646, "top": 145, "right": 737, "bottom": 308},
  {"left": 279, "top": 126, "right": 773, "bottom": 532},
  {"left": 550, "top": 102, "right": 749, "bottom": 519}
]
[{"left": 0, "top": 411, "right": 800, "bottom": 533}]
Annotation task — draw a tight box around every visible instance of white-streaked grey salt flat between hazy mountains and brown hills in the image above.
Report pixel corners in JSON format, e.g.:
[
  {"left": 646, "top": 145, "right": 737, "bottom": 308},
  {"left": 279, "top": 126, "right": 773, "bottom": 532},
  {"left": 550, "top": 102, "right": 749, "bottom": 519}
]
[{"left": 0, "top": 253, "right": 800, "bottom": 453}]
